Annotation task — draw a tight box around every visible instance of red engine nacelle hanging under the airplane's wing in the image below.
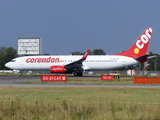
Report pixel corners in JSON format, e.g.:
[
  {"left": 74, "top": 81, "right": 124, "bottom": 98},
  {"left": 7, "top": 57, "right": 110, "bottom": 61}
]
[{"left": 50, "top": 66, "right": 66, "bottom": 73}]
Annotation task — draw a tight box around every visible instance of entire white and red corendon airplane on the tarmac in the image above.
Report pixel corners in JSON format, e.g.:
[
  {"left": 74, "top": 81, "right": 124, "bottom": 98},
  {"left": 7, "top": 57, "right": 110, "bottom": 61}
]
[{"left": 5, "top": 28, "right": 153, "bottom": 76}]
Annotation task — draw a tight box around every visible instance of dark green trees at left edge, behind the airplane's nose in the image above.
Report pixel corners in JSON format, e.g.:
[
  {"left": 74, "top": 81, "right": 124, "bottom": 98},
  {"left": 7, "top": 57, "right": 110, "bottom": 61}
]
[{"left": 0, "top": 47, "right": 17, "bottom": 70}]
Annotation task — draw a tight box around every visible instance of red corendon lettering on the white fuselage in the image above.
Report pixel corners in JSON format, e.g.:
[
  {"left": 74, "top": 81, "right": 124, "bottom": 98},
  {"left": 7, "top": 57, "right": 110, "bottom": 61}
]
[{"left": 26, "top": 57, "right": 60, "bottom": 63}]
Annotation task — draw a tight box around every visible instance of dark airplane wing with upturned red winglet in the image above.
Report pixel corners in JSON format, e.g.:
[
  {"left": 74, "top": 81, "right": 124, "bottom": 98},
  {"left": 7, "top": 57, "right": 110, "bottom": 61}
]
[{"left": 64, "top": 49, "right": 90, "bottom": 69}]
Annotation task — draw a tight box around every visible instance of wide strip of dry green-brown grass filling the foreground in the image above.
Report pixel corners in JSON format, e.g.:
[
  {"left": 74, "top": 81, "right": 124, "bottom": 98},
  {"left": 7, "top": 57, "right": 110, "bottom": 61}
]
[{"left": 0, "top": 87, "right": 160, "bottom": 120}]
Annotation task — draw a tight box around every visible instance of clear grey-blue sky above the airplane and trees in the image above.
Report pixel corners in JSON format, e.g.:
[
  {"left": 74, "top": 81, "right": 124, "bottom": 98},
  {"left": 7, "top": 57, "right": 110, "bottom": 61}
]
[{"left": 0, "top": 0, "right": 160, "bottom": 55}]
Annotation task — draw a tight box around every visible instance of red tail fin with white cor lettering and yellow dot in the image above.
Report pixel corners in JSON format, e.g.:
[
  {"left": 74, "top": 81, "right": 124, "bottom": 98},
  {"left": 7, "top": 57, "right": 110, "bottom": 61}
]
[{"left": 116, "top": 28, "right": 152, "bottom": 58}]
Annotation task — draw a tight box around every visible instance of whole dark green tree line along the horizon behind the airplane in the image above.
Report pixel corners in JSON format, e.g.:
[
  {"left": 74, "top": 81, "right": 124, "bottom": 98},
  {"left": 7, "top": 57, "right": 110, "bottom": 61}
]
[{"left": 0, "top": 47, "right": 160, "bottom": 71}]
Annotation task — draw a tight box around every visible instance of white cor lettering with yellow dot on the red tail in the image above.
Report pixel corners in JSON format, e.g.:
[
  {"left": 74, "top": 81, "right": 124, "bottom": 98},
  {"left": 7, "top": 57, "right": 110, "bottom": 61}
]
[{"left": 134, "top": 28, "right": 152, "bottom": 54}]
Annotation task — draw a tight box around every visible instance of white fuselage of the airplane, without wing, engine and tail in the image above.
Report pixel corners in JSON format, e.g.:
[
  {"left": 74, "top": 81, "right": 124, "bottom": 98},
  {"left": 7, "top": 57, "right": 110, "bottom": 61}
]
[{"left": 5, "top": 55, "right": 138, "bottom": 71}]
